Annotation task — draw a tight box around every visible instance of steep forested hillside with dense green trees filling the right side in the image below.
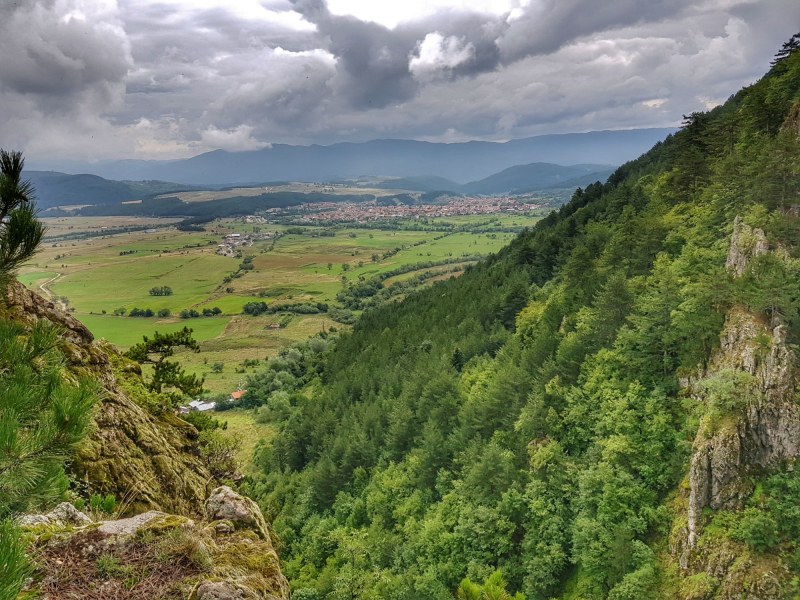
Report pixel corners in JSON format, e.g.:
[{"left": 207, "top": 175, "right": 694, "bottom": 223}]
[{"left": 242, "top": 38, "right": 800, "bottom": 600}]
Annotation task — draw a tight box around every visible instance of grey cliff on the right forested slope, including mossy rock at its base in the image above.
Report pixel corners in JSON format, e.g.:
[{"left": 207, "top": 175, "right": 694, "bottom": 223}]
[{"left": 673, "top": 218, "right": 800, "bottom": 598}]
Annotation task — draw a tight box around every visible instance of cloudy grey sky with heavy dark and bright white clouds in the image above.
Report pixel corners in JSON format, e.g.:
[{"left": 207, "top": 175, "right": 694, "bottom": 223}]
[{"left": 0, "top": 0, "right": 800, "bottom": 161}]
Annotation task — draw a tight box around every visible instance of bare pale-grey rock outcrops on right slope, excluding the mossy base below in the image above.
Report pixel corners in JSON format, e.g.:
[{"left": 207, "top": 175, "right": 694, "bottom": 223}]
[{"left": 684, "top": 217, "right": 800, "bottom": 552}]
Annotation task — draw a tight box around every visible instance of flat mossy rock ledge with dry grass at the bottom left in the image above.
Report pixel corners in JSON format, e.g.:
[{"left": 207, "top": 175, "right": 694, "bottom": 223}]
[{"left": 20, "top": 488, "right": 289, "bottom": 600}]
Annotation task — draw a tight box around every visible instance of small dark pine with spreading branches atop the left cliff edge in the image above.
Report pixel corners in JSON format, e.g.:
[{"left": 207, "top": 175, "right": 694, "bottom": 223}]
[{"left": 125, "top": 327, "right": 203, "bottom": 401}]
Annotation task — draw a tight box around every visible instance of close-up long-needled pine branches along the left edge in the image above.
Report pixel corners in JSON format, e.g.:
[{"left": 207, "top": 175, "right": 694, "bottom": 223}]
[{"left": 0, "top": 150, "right": 96, "bottom": 600}]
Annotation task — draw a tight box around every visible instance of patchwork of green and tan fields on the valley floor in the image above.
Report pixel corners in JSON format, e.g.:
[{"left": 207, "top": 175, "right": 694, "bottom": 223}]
[{"left": 19, "top": 215, "right": 536, "bottom": 393}]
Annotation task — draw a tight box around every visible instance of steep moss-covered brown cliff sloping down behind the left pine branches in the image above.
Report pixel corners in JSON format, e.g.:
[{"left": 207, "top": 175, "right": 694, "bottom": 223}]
[{"left": 2, "top": 283, "right": 211, "bottom": 514}]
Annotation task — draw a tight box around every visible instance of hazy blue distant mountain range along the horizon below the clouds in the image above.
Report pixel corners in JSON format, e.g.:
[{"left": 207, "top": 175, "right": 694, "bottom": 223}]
[{"left": 29, "top": 128, "right": 675, "bottom": 185}]
